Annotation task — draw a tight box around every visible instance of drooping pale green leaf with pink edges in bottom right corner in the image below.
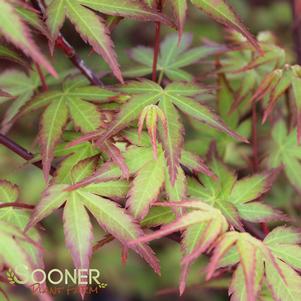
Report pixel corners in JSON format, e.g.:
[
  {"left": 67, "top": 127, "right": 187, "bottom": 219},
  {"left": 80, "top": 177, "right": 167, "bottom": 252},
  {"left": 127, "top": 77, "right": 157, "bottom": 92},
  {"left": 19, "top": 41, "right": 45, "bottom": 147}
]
[{"left": 207, "top": 227, "right": 301, "bottom": 301}]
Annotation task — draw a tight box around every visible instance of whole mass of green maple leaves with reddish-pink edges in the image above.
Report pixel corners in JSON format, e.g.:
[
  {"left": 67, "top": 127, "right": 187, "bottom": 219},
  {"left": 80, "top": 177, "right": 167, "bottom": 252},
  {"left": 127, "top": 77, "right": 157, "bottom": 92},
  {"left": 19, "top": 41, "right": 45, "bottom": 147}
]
[{"left": 0, "top": 0, "right": 301, "bottom": 301}]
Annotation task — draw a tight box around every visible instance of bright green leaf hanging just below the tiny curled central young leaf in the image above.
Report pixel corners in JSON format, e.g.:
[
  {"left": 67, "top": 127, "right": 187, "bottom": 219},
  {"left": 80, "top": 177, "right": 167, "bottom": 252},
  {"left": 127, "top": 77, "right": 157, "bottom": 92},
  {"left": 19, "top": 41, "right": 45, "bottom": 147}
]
[{"left": 67, "top": 131, "right": 213, "bottom": 219}]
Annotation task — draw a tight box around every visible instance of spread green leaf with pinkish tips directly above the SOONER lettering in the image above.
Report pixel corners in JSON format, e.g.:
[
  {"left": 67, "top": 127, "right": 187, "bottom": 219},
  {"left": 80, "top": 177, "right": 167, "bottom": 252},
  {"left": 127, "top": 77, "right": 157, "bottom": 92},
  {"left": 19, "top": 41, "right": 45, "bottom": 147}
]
[{"left": 27, "top": 157, "right": 160, "bottom": 286}]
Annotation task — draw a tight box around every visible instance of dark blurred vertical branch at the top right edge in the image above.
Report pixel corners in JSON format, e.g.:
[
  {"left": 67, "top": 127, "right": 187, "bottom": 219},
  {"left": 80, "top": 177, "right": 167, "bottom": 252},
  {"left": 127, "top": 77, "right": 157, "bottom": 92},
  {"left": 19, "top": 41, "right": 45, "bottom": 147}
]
[{"left": 290, "top": 0, "right": 301, "bottom": 65}]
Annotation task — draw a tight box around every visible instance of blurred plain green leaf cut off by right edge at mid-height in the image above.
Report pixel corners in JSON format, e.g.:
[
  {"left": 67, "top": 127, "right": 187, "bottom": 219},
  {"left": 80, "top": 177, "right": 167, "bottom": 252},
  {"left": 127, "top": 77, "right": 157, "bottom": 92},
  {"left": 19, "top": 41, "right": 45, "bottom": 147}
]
[{"left": 266, "top": 120, "right": 301, "bottom": 193}]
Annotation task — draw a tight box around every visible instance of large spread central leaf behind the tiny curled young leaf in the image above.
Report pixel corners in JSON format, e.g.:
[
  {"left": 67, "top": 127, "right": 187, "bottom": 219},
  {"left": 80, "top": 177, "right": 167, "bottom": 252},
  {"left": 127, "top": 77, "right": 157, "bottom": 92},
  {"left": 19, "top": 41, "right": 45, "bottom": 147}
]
[{"left": 70, "top": 80, "right": 247, "bottom": 184}]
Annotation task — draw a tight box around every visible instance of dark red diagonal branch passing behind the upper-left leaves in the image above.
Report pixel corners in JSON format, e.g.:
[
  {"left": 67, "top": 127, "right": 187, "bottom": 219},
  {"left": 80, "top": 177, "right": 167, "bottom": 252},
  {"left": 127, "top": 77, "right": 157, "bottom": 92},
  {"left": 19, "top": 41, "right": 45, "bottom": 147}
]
[{"left": 32, "top": 0, "right": 102, "bottom": 86}]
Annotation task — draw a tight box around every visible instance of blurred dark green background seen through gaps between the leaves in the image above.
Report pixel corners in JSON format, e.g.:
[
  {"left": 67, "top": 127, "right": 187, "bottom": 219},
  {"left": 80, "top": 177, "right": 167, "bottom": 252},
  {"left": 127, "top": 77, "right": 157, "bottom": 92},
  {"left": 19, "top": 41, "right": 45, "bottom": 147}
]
[{"left": 0, "top": 0, "right": 300, "bottom": 301}]
